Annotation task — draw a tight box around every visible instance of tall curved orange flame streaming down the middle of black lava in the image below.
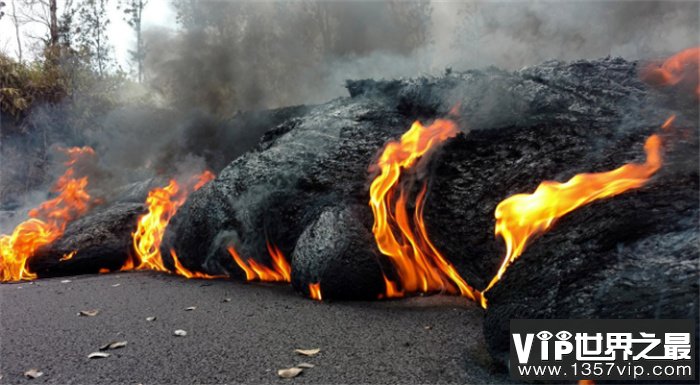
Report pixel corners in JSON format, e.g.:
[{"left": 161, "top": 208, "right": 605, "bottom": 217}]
[{"left": 369, "top": 119, "right": 479, "bottom": 300}]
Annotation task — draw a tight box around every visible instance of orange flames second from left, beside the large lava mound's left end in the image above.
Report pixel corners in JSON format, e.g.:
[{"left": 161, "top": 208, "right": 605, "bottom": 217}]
[{"left": 121, "top": 171, "right": 214, "bottom": 278}]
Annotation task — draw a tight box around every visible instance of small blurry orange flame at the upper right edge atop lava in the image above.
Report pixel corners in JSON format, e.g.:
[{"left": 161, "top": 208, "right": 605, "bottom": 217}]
[{"left": 641, "top": 47, "right": 700, "bottom": 95}]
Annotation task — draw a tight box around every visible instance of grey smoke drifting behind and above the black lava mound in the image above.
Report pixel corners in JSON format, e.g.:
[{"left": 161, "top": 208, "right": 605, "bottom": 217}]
[{"left": 0, "top": 0, "right": 700, "bottom": 224}]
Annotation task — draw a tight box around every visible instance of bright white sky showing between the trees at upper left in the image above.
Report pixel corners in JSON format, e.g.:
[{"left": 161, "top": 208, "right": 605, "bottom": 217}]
[{"left": 0, "top": 0, "right": 176, "bottom": 70}]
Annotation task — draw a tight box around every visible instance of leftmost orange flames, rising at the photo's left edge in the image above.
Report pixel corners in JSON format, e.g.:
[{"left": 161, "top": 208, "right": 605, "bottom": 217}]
[{"left": 0, "top": 147, "right": 95, "bottom": 282}]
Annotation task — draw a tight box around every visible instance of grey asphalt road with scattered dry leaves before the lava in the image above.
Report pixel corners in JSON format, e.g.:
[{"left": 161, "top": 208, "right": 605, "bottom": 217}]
[{"left": 0, "top": 272, "right": 509, "bottom": 384}]
